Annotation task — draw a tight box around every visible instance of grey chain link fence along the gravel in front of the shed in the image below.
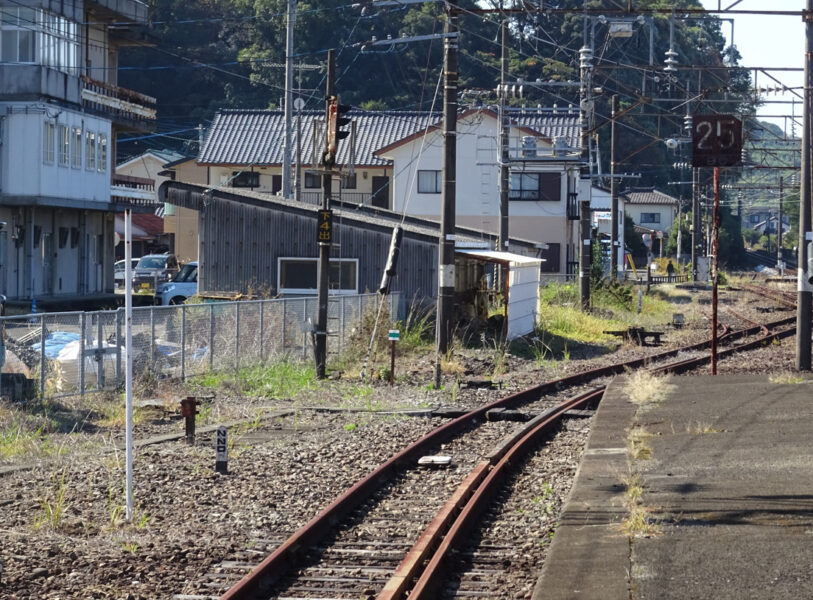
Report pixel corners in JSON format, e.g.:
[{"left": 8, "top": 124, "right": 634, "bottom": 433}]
[{"left": 0, "top": 294, "right": 404, "bottom": 397}]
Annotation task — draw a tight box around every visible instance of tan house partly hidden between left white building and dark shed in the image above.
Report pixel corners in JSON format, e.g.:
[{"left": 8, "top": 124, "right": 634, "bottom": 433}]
[{"left": 116, "top": 150, "right": 207, "bottom": 263}]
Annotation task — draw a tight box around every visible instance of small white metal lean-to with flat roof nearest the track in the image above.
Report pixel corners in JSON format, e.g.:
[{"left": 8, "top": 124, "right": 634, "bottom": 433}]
[{"left": 455, "top": 250, "right": 542, "bottom": 340}]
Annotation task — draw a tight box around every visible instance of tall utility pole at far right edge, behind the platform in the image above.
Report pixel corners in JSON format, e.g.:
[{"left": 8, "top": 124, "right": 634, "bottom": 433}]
[{"left": 796, "top": 0, "right": 813, "bottom": 371}]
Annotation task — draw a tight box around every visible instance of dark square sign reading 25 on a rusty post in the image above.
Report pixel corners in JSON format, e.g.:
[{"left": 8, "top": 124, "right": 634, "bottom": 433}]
[{"left": 692, "top": 115, "right": 742, "bottom": 167}]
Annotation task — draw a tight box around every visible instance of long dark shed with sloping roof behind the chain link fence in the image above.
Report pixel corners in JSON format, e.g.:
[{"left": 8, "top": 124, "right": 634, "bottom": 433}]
[{"left": 159, "top": 181, "right": 539, "bottom": 312}]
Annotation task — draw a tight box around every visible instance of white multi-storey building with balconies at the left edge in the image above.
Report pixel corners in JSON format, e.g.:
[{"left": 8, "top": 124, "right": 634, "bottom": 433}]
[{"left": 0, "top": 0, "right": 155, "bottom": 308}]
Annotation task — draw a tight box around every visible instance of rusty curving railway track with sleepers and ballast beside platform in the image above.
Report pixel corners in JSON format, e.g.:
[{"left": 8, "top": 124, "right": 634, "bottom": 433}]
[{"left": 176, "top": 292, "right": 795, "bottom": 600}]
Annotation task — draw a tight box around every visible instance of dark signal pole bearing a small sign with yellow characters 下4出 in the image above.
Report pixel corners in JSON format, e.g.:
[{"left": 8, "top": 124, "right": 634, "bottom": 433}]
[{"left": 314, "top": 50, "right": 336, "bottom": 379}]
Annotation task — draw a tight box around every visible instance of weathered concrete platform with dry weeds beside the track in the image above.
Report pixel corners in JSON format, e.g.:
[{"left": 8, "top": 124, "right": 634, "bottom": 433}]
[{"left": 533, "top": 376, "right": 813, "bottom": 600}]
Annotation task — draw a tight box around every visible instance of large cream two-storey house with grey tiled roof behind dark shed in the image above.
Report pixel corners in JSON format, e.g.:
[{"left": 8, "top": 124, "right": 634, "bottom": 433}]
[{"left": 198, "top": 108, "right": 590, "bottom": 273}]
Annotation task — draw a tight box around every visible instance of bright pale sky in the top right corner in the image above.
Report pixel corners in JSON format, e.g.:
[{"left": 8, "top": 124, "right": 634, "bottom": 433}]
[{"left": 701, "top": 0, "right": 806, "bottom": 135}]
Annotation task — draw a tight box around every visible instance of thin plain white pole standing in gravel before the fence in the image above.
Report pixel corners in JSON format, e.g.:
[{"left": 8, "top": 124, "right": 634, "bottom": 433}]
[{"left": 124, "top": 209, "right": 133, "bottom": 521}]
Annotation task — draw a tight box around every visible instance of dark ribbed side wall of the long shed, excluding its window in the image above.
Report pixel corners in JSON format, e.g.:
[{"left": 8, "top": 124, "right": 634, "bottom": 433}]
[{"left": 167, "top": 189, "right": 438, "bottom": 302}]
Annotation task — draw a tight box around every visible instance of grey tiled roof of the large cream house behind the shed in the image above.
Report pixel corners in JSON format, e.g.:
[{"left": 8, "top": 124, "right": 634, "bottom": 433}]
[{"left": 198, "top": 109, "right": 579, "bottom": 166}]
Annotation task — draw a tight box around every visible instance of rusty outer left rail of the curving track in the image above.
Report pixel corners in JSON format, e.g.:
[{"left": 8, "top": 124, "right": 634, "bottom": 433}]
[{"left": 220, "top": 312, "right": 800, "bottom": 600}]
